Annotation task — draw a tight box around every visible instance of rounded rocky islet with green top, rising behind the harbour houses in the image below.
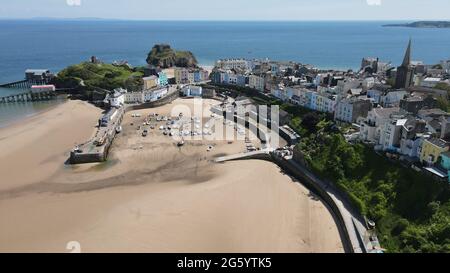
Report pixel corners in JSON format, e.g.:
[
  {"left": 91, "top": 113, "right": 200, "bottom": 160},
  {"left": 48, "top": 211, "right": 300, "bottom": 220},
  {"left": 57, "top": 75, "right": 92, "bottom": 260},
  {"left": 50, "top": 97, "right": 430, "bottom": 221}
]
[{"left": 147, "top": 44, "right": 197, "bottom": 68}]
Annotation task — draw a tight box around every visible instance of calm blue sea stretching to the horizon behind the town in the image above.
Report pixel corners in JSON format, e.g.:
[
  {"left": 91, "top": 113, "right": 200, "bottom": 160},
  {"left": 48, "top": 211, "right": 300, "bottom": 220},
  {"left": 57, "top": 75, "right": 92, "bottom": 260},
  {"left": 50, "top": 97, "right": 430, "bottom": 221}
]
[{"left": 0, "top": 20, "right": 450, "bottom": 126}]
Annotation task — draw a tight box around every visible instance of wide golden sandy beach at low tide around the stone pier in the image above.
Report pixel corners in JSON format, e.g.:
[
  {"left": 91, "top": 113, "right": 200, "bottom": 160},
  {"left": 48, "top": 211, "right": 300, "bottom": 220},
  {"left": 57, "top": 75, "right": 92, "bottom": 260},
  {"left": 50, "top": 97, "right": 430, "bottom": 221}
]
[{"left": 0, "top": 99, "right": 343, "bottom": 252}]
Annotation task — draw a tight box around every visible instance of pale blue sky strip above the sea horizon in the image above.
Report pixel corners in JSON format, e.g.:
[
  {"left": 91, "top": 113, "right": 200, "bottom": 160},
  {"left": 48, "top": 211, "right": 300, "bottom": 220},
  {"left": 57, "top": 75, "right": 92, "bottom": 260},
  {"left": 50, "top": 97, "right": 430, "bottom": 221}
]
[{"left": 0, "top": 0, "right": 450, "bottom": 20}]
